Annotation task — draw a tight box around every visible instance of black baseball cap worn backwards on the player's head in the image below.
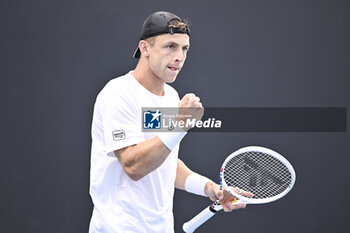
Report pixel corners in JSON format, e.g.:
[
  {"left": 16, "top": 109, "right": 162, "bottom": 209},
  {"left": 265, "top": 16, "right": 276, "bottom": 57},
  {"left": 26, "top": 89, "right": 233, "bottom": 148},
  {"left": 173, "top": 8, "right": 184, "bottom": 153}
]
[{"left": 133, "top": 11, "right": 190, "bottom": 58}]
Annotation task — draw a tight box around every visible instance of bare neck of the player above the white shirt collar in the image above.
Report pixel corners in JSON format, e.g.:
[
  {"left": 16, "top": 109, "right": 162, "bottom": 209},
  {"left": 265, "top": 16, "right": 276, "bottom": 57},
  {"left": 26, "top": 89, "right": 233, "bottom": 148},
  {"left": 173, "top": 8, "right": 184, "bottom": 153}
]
[{"left": 132, "top": 62, "right": 165, "bottom": 96}]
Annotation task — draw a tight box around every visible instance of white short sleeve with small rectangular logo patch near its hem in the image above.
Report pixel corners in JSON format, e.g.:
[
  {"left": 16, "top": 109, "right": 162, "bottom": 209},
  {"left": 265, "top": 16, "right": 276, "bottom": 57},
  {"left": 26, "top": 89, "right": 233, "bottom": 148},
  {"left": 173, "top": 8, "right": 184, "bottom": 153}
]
[{"left": 99, "top": 92, "right": 144, "bottom": 156}]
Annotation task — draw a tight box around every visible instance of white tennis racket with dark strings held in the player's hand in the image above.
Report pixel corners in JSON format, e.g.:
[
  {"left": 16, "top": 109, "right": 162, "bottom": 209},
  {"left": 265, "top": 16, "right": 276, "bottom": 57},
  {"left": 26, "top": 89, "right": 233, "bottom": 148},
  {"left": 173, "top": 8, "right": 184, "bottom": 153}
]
[{"left": 182, "top": 146, "right": 295, "bottom": 233}]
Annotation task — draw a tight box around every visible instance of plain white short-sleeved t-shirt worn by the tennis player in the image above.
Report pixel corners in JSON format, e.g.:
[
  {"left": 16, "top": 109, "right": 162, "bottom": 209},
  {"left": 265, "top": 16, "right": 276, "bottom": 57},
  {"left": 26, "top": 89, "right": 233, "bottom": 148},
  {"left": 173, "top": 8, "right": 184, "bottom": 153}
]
[{"left": 89, "top": 71, "right": 180, "bottom": 233}]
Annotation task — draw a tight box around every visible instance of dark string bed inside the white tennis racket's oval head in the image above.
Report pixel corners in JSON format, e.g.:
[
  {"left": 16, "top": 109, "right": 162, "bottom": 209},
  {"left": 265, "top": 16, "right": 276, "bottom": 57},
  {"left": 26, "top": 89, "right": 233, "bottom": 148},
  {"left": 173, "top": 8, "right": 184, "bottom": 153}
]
[{"left": 223, "top": 151, "right": 292, "bottom": 199}]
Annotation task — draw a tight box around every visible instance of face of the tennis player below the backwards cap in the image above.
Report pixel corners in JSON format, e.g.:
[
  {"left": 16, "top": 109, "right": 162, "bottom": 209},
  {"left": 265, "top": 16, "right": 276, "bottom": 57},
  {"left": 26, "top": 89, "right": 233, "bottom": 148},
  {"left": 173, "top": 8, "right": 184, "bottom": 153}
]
[{"left": 148, "top": 33, "right": 190, "bottom": 83}]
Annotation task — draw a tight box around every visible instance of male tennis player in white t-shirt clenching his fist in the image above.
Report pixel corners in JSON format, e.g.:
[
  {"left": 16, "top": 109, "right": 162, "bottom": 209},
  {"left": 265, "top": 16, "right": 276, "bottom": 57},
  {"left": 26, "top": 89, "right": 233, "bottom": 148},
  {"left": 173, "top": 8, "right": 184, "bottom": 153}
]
[{"left": 89, "top": 12, "right": 249, "bottom": 233}]
